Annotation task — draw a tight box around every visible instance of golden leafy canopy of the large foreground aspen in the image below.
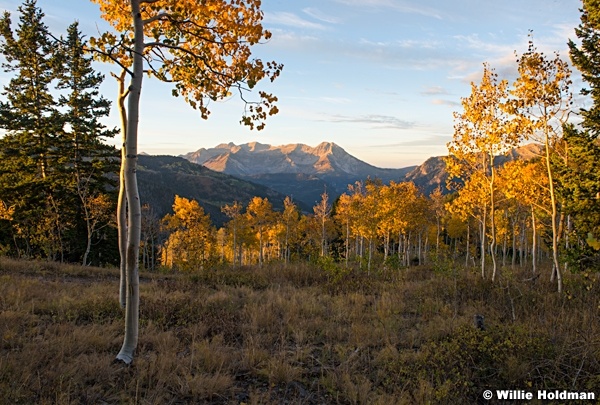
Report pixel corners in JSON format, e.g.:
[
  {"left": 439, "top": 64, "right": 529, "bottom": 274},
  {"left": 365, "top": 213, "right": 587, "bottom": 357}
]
[{"left": 90, "top": 0, "right": 283, "bottom": 130}]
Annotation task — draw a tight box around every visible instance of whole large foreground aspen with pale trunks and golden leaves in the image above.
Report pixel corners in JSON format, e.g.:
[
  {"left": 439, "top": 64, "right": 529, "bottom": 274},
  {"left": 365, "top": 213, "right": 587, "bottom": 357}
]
[{"left": 90, "top": 0, "right": 282, "bottom": 364}]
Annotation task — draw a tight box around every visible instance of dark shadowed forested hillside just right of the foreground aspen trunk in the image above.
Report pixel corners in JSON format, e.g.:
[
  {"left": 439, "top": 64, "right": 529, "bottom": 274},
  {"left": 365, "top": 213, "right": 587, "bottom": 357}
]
[{"left": 137, "top": 155, "right": 298, "bottom": 226}]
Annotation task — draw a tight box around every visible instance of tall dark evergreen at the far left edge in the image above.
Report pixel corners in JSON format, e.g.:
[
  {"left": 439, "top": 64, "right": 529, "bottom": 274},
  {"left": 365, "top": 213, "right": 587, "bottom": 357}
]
[{"left": 0, "top": 0, "right": 62, "bottom": 258}]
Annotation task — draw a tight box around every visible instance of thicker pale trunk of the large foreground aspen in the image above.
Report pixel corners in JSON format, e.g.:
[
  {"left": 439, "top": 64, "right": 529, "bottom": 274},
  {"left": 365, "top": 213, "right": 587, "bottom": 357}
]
[{"left": 117, "top": 0, "right": 144, "bottom": 364}]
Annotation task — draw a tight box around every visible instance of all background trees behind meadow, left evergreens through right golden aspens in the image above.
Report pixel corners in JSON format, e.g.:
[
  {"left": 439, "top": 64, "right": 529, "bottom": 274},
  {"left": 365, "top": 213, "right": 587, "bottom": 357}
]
[{"left": 0, "top": 0, "right": 600, "bottom": 290}]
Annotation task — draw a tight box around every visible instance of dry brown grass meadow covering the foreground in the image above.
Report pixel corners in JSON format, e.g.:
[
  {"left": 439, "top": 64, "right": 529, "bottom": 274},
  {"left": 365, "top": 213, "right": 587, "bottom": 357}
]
[{"left": 0, "top": 259, "right": 600, "bottom": 404}]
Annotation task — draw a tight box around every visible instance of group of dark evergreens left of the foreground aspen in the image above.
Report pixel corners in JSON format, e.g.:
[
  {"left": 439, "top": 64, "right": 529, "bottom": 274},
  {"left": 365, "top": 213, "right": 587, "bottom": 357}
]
[{"left": 0, "top": 0, "right": 118, "bottom": 265}]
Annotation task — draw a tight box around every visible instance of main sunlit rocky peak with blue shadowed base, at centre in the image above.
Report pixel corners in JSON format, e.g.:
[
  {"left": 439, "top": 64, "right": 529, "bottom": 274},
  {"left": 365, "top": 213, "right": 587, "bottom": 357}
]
[{"left": 182, "top": 142, "right": 414, "bottom": 206}]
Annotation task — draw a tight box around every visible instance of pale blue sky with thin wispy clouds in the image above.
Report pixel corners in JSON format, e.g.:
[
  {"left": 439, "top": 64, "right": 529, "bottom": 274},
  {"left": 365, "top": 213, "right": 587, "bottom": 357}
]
[{"left": 0, "top": 0, "right": 581, "bottom": 168}]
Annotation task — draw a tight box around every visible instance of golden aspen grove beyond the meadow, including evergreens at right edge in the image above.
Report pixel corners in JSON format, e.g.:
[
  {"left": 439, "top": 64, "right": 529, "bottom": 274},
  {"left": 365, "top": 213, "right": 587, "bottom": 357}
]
[{"left": 145, "top": 1, "right": 600, "bottom": 282}]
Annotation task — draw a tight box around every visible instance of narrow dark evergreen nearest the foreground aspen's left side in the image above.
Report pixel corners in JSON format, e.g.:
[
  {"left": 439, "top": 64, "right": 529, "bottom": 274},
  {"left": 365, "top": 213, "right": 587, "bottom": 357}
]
[{"left": 56, "top": 22, "right": 118, "bottom": 265}]
